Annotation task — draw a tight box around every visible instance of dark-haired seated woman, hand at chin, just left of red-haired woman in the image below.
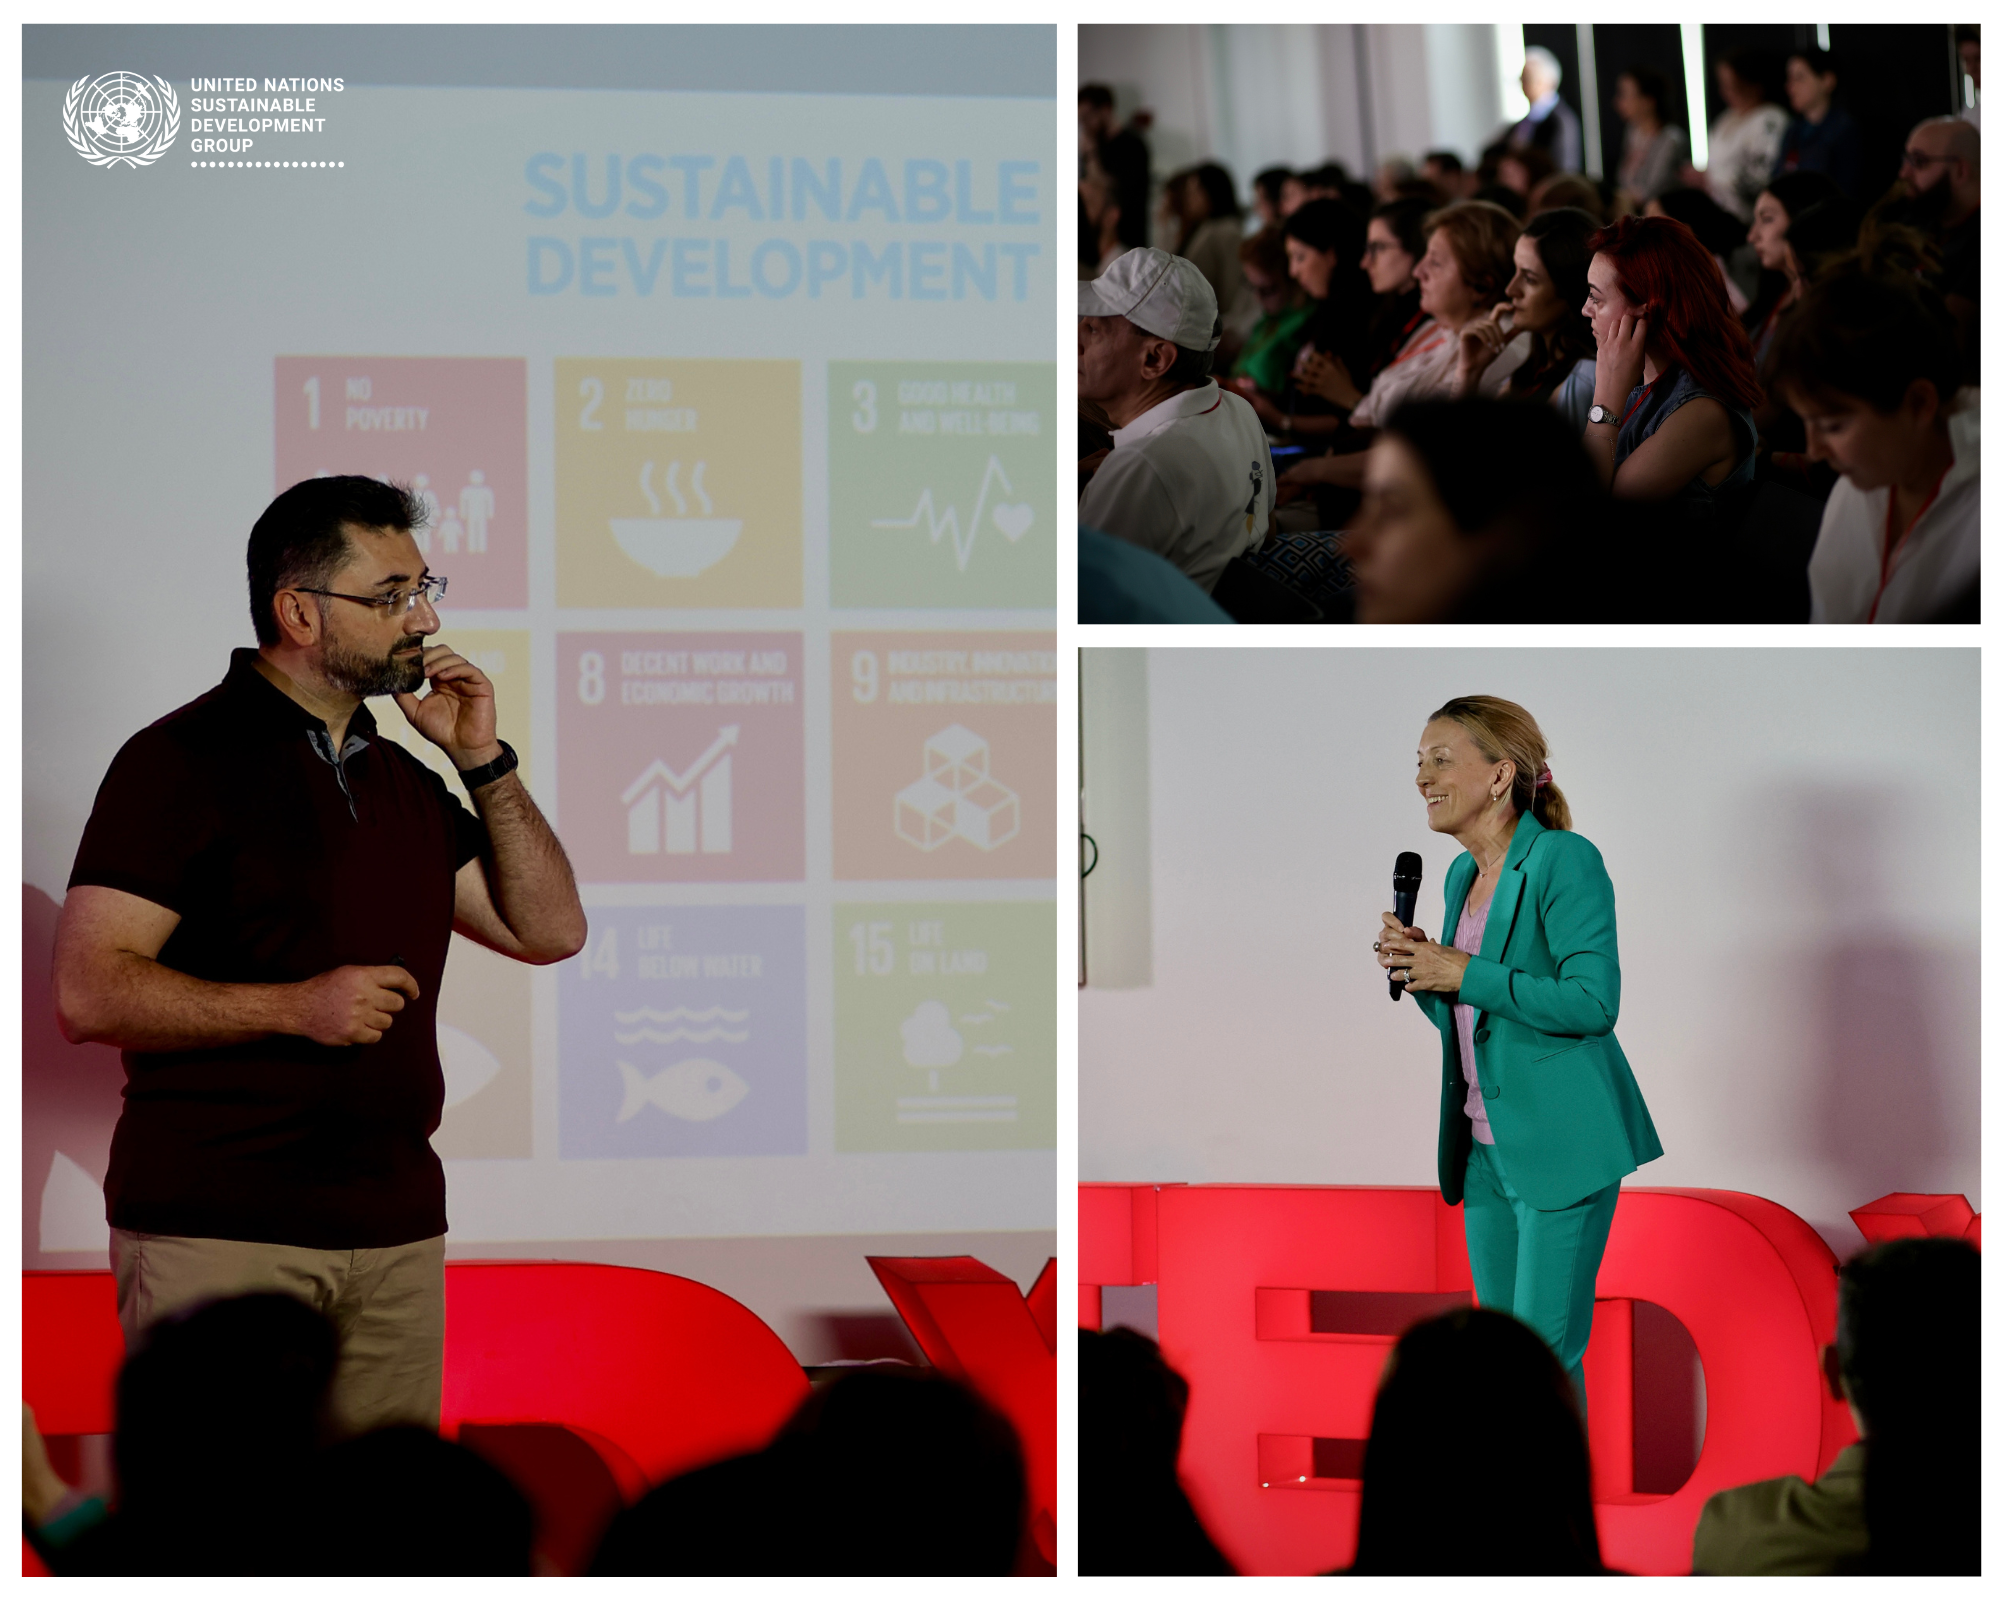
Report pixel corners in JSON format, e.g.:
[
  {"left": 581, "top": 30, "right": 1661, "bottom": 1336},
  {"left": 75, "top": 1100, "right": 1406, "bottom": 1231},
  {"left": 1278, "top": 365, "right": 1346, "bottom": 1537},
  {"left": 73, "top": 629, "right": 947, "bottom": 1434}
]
[{"left": 1452, "top": 210, "right": 1600, "bottom": 406}]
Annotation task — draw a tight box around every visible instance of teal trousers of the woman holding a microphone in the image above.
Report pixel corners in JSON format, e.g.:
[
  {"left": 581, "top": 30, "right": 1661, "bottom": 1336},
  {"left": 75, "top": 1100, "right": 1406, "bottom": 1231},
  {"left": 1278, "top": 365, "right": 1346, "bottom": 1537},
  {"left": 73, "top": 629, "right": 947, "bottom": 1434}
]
[{"left": 1466, "top": 1140, "right": 1618, "bottom": 1410}]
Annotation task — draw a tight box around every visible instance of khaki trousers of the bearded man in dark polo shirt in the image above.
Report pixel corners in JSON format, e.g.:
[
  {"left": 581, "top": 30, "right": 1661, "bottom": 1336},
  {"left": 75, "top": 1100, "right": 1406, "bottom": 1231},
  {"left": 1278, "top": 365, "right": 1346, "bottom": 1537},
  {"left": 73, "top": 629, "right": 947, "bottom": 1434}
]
[{"left": 112, "top": 1228, "right": 444, "bottom": 1434}]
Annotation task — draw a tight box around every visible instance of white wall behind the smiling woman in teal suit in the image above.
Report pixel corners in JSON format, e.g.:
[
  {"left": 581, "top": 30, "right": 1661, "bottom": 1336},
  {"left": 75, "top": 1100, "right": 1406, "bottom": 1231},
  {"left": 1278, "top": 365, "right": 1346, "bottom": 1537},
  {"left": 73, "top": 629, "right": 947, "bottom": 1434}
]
[{"left": 1078, "top": 648, "right": 1980, "bottom": 1252}]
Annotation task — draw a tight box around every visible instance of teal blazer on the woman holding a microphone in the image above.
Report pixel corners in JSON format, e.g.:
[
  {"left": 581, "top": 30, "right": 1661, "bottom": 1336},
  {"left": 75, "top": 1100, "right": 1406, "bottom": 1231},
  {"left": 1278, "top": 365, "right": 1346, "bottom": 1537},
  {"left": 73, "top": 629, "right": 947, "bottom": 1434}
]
[{"left": 1412, "top": 816, "right": 1660, "bottom": 1212}]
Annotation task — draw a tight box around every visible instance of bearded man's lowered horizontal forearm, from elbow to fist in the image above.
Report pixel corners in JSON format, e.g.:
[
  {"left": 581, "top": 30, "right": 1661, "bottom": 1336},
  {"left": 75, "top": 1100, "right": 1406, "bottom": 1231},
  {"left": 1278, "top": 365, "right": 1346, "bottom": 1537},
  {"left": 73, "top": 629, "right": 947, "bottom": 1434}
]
[{"left": 56, "top": 950, "right": 298, "bottom": 1050}]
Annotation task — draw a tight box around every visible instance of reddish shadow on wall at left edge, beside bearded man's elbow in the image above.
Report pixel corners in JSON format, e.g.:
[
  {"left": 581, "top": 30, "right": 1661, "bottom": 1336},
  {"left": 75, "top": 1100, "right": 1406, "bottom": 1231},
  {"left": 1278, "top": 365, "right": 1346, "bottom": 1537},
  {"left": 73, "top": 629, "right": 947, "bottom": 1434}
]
[{"left": 20, "top": 884, "right": 124, "bottom": 1268}]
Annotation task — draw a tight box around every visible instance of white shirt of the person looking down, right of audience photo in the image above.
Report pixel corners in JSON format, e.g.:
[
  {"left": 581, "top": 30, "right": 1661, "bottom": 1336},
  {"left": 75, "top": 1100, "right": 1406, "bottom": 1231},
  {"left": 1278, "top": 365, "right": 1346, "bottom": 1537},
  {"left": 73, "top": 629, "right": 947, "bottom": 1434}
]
[{"left": 1808, "top": 388, "right": 1980, "bottom": 622}]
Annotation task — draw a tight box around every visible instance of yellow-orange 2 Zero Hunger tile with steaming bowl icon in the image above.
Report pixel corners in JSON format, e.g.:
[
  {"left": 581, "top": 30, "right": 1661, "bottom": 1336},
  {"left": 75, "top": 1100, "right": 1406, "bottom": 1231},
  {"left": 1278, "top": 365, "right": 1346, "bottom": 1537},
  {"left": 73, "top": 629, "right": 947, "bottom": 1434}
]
[{"left": 556, "top": 360, "right": 804, "bottom": 608}]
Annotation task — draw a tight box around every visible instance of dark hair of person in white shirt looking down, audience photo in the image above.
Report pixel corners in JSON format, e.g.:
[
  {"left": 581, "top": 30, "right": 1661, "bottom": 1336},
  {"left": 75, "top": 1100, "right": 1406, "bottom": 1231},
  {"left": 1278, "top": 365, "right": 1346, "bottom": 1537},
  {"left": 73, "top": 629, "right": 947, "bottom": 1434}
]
[{"left": 1770, "top": 266, "right": 1964, "bottom": 416}]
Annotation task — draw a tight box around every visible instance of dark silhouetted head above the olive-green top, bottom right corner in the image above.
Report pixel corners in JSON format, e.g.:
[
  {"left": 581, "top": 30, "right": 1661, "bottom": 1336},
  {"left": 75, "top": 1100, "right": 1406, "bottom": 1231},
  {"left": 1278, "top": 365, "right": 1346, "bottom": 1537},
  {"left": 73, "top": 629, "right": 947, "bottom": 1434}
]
[{"left": 1826, "top": 1238, "right": 1980, "bottom": 1576}]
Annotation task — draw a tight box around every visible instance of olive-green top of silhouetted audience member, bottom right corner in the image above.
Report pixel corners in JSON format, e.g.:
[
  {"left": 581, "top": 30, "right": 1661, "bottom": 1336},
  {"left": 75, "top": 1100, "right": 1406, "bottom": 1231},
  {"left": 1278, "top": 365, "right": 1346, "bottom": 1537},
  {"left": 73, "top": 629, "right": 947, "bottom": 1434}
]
[{"left": 1694, "top": 1444, "right": 1868, "bottom": 1578}]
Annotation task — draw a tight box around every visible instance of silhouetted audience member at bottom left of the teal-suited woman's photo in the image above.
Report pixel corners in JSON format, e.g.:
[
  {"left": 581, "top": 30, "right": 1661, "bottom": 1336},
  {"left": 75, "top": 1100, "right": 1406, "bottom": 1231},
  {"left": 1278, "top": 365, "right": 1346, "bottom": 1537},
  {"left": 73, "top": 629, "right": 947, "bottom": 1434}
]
[{"left": 1076, "top": 1328, "right": 1234, "bottom": 1578}]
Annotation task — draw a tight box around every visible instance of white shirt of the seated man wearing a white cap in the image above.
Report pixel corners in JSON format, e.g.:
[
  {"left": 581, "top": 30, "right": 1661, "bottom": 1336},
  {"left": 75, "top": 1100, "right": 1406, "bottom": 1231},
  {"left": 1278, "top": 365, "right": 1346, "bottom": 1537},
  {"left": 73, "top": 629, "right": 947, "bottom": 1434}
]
[{"left": 1076, "top": 380, "right": 1272, "bottom": 590}]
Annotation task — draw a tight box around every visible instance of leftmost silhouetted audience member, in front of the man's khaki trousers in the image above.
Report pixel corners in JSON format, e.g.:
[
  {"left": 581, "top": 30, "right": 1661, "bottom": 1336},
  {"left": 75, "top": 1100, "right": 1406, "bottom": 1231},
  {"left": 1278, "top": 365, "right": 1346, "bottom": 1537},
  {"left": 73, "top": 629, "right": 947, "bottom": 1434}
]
[{"left": 28, "top": 1294, "right": 338, "bottom": 1576}]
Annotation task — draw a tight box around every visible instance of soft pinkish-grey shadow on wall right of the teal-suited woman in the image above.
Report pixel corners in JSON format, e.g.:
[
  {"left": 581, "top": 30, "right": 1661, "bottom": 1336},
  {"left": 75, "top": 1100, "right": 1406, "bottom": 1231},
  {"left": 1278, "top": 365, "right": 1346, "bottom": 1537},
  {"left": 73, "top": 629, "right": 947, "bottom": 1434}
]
[{"left": 1794, "top": 790, "right": 1978, "bottom": 1204}]
